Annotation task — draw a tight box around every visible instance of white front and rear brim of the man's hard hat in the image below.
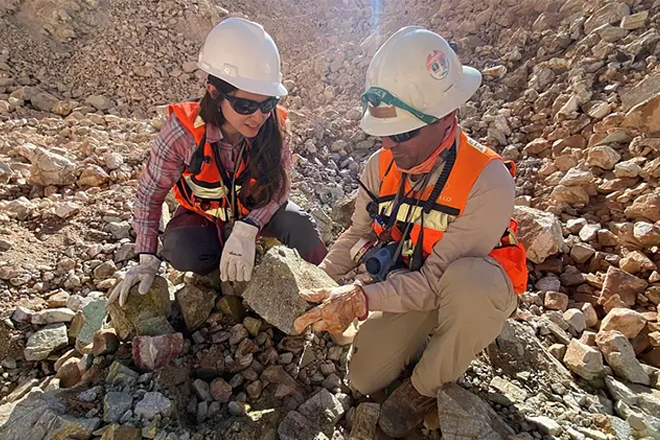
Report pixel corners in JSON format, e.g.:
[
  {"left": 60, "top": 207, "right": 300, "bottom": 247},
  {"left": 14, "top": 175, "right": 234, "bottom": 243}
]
[{"left": 360, "top": 66, "right": 481, "bottom": 137}]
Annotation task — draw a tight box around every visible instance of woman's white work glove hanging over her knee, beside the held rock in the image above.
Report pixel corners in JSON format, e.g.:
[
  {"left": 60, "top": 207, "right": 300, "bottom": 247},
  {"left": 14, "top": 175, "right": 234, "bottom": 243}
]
[{"left": 220, "top": 221, "right": 259, "bottom": 281}]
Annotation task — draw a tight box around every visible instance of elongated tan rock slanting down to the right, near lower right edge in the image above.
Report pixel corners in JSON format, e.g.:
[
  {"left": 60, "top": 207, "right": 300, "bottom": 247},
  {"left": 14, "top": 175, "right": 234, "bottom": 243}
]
[{"left": 596, "top": 329, "right": 651, "bottom": 385}]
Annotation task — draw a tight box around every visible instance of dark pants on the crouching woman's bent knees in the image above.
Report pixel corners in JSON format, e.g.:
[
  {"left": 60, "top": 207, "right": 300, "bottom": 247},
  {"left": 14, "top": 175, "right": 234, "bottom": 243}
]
[{"left": 162, "top": 202, "right": 328, "bottom": 275}]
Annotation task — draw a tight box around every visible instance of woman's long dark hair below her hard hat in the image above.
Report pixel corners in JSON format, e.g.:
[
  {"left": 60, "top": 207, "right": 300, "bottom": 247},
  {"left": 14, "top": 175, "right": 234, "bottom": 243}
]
[{"left": 199, "top": 75, "right": 288, "bottom": 209}]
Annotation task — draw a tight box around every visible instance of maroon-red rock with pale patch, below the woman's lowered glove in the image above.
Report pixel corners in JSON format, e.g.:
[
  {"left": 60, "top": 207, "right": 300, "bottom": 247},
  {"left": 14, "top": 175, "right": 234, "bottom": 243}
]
[{"left": 132, "top": 333, "right": 184, "bottom": 371}]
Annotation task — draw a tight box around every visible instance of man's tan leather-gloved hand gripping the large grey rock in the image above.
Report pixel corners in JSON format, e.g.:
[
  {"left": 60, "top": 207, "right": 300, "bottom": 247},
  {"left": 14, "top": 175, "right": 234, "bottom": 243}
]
[{"left": 293, "top": 284, "right": 369, "bottom": 334}]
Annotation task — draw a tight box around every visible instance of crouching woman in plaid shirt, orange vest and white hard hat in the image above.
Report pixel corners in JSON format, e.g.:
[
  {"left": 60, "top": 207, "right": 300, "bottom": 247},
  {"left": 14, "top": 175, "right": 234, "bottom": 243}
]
[{"left": 110, "top": 18, "right": 327, "bottom": 306}]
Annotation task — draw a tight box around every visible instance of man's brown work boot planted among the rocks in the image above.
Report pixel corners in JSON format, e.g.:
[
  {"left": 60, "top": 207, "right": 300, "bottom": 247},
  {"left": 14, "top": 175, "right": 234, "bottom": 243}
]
[{"left": 378, "top": 379, "right": 436, "bottom": 438}]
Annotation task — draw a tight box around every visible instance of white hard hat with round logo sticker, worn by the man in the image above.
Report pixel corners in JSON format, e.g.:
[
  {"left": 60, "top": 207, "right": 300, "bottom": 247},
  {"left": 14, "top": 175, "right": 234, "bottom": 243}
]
[{"left": 360, "top": 26, "right": 481, "bottom": 136}]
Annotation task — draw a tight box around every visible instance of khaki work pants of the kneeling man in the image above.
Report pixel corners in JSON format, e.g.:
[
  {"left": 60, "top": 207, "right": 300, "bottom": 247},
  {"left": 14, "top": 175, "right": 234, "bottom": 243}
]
[{"left": 349, "top": 257, "right": 518, "bottom": 397}]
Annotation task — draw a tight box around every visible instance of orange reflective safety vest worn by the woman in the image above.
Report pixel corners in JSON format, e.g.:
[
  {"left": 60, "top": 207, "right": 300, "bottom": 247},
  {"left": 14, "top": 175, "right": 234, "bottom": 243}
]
[{"left": 168, "top": 102, "right": 288, "bottom": 222}]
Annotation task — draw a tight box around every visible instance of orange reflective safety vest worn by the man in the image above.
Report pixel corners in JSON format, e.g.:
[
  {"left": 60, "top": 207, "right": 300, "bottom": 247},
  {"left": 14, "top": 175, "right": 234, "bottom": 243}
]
[{"left": 373, "top": 132, "right": 528, "bottom": 293}]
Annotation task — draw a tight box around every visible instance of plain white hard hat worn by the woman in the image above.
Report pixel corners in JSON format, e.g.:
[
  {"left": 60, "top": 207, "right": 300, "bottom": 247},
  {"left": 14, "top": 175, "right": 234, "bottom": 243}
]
[{"left": 197, "top": 17, "right": 287, "bottom": 96}]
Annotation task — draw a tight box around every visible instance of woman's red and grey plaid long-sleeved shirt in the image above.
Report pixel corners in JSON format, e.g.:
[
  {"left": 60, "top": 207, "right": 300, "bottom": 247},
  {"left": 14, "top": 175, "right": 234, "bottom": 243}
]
[{"left": 133, "top": 115, "right": 292, "bottom": 254}]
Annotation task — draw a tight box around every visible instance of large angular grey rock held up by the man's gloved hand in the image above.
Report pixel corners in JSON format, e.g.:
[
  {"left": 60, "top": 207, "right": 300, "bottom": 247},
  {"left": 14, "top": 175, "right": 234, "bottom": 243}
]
[{"left": 243, "top": 246, "right": 337, "bottom": 335}]
